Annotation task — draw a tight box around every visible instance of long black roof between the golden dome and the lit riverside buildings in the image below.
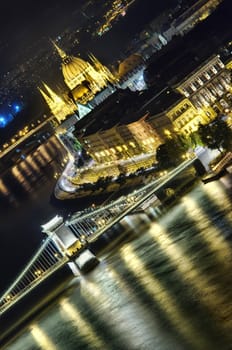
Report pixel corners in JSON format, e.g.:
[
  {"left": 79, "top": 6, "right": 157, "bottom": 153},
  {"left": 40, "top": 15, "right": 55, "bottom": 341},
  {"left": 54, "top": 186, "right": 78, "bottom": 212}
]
[{"left": 75, "top": 88, "right": 183, "bottom": 137}]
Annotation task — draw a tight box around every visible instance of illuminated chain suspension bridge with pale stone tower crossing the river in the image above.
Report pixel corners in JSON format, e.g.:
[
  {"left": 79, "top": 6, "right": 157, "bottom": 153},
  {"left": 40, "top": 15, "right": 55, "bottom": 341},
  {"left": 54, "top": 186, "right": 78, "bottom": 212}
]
[{"left": 0, "top": 158, "right": 196, "bottom": 315}]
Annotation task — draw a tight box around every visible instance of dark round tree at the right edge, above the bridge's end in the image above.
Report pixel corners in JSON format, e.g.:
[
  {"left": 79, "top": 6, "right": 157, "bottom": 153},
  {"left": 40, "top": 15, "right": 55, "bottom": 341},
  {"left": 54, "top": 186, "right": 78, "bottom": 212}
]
[{"left": 198, "top": 118, "right": 232, "bottom": 152}]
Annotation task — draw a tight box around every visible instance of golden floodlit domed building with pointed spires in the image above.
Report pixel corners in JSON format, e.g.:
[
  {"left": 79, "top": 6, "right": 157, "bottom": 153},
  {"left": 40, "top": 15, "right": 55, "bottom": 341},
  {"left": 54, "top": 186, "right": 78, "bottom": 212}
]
[{"left": 39, "top": 42, "right": 117, "bottom": 124}]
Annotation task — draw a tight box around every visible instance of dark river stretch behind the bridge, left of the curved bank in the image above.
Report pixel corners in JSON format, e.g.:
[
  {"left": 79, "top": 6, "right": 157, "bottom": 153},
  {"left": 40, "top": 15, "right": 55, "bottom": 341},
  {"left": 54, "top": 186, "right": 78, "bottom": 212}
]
[{"left": 0, "top": 137, "right": 70, "bottom": 291}]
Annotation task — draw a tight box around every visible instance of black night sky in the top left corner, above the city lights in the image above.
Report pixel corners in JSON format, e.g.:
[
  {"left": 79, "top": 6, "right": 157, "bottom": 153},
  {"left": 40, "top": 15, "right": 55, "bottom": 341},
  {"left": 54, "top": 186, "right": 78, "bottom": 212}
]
[{"left": 0, "top": 0, "right": 83, "bottom": 72}]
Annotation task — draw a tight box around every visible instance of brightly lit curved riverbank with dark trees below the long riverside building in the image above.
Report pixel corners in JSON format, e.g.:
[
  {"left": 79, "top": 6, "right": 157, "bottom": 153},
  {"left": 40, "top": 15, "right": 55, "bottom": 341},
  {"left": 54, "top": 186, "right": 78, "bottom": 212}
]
[{"left": 54, "top": 153, "right": 158, "bottom": 200}]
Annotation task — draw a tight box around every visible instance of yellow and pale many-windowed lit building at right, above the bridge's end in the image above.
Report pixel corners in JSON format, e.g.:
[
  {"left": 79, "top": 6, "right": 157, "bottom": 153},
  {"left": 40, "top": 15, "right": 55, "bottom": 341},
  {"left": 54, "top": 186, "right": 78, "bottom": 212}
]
[{"left": 150, "top": 55, "right": 232, "bottom": 135}]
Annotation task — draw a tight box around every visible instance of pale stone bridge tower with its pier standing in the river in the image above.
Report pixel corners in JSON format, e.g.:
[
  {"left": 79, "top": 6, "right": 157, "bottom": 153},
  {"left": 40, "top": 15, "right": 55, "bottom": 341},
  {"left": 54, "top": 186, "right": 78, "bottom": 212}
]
[{"left": 42, "top": 215, "right": 99, "bottom": 276}]
